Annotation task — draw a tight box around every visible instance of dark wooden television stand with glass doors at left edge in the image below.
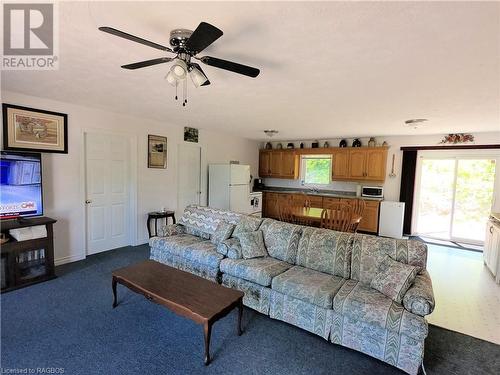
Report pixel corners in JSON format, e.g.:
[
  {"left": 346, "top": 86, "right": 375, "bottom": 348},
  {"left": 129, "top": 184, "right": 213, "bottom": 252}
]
[{"left": 0, "top": 216, "right": 57, "bottom": 293}]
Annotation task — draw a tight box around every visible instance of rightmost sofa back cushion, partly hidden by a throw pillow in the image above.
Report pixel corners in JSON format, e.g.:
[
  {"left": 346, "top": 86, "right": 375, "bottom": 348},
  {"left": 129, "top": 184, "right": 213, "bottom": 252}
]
[{"left": 351, "top": 234, "right": 427, "bottom": 285}]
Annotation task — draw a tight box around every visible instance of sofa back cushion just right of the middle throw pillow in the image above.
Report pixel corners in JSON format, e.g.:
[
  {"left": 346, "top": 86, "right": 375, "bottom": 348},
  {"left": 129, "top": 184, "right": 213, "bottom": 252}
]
[{"left": 259, "top": 219, "right": 302, "bottom": 264}]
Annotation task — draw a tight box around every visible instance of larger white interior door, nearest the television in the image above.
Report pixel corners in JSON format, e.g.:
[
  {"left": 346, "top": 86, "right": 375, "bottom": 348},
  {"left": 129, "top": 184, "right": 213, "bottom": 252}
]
[{"left": 85, "top": 133, "right": 130, "bottom": 255}]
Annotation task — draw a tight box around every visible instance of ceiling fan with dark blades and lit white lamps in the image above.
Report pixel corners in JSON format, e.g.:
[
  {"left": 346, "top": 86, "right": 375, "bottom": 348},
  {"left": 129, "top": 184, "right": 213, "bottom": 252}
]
[{"left": 99, "top": 22, "right": 260, "bottom": 105}]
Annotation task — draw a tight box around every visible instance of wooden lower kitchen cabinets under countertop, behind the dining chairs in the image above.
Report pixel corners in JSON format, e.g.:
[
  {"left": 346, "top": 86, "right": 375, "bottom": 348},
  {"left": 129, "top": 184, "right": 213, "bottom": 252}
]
[{"left": 262, "top": 192, "right": 380, "bottom": 234}]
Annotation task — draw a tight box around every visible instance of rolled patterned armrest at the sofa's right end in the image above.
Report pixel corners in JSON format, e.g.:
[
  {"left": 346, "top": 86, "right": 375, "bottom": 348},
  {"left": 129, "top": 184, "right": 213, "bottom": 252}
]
[{"left": 403, "top": 270, "right": 435, "bottom": 316}]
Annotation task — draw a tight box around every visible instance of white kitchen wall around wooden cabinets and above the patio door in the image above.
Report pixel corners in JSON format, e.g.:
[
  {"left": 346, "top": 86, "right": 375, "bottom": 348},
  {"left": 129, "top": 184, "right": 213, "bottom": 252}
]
[{"left": 261, "top": 131, "right": 500, "bottom": 201}]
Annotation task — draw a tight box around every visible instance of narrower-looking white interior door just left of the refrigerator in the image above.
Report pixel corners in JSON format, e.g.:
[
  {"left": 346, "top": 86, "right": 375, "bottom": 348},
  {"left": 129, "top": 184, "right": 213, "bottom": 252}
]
[{"left": 177, "top": 144, "right": 201, "bottom": 212}]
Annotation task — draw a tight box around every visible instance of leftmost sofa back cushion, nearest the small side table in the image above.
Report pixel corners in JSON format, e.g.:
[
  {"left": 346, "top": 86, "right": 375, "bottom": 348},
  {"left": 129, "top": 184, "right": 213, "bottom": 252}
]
[{"left": 179, "top": 205, "right": 242, "bottom": 235}]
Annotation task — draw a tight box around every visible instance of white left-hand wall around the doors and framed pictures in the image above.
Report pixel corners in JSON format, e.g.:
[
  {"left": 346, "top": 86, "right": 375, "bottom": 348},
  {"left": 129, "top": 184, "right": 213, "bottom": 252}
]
[{"left": 1, "top": 91, "right": 258, "bottom": 264}]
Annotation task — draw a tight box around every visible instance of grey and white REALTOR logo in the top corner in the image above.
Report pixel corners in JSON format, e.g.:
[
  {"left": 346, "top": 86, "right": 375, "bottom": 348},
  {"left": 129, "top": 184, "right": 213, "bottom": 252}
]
[{"left": 2, "top": 2, "right": 57, "bottom": 70}]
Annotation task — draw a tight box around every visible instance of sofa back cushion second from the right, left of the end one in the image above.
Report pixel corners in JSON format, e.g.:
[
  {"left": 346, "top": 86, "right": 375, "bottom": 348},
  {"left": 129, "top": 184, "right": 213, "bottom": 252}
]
[{"left": 295, "top": 227, "right": 354, "bottom": 279}]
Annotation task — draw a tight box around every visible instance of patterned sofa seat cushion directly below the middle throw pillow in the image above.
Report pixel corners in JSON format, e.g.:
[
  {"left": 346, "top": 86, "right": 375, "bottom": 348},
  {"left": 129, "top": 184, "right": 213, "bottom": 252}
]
[{"left": 220, "top": 257, "right": 292, "bottom": 286}]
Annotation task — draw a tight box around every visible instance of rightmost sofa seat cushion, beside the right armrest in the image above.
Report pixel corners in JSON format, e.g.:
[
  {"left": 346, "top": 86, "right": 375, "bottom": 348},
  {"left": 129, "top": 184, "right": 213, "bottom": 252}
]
[{"left": 333, "top": 280, "right": 428, "bottom": 340}]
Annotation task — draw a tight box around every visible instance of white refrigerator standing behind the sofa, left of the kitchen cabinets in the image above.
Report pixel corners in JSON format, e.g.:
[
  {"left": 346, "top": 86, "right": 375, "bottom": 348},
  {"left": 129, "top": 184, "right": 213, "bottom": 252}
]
[{"left": 208, "top": 164, "right": 251, "bottom": 214}]
